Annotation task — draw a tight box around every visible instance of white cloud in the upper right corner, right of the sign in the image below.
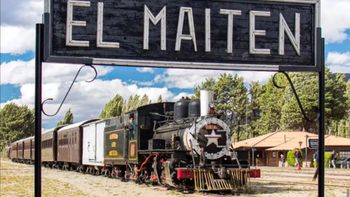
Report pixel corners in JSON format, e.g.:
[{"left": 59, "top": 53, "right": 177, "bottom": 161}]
[{"left": 321, "top": 0, "right": 350, "bottom": 43}]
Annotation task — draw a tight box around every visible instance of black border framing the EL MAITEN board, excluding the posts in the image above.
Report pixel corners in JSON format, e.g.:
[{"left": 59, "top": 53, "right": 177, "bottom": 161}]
[{"left": 44, "top": 0, "right": 320, "bottom": 71}]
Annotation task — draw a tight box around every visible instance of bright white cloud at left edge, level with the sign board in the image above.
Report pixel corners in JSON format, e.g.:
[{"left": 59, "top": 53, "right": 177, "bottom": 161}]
[{"left": 0, "top": 25, "right": 35, "bottom": 54}]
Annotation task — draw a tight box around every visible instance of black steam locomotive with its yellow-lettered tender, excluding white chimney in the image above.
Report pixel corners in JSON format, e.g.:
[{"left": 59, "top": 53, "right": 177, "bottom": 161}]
[{"left": 100, "top": 99, "right": 248, "bottom": 191}]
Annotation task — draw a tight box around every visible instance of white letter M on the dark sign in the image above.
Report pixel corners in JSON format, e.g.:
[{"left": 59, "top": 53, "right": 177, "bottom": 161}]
[{"left": 143, "top": 5, "right": 166, "bottom": 51}]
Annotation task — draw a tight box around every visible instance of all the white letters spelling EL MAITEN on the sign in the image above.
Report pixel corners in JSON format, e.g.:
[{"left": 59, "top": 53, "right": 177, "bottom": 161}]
[{"left": 66, "top": 3, "right": 301, "bottom": 56}]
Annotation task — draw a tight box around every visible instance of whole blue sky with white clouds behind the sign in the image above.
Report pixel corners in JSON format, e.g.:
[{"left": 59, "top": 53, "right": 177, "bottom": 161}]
[{"left": 0, "top": 0, "right": 350, "bottom": 128}]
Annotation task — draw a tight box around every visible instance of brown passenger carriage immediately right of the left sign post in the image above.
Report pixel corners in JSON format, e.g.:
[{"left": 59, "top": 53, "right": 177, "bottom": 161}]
[{"left": 41, "top": 126, "right": 63, "bottom": 165}]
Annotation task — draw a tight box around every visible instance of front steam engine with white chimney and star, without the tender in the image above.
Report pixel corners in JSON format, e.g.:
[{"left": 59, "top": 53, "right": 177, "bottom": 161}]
[{"left": 148, "top": 91, "right": 248, "bottom": 191}]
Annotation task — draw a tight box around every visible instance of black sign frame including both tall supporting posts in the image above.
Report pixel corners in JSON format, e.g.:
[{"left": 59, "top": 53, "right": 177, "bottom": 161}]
[{"left": 34, "top": 0, "right": 325, "bottom": 197}]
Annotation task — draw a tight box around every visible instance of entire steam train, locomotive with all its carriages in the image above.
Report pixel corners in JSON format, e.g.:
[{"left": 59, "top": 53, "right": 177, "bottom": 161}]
[{"left": 8, "top": 91, "right": 249, "bottom": 191}]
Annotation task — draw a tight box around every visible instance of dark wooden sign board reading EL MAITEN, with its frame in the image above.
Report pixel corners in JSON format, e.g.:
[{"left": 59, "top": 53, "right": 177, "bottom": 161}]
[{"left": 45, "top": 0, "right": 319, "bottom": 71}]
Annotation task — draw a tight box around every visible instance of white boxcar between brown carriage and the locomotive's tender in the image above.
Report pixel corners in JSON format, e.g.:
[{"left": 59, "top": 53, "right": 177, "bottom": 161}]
[{"left": 83, "top": 120, "right": 106, "bottom": 166}]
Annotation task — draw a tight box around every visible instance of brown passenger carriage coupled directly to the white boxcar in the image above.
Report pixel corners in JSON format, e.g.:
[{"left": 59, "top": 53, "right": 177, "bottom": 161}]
[{"left": 57, "top": 119, "right": 96, "bottom": 166}]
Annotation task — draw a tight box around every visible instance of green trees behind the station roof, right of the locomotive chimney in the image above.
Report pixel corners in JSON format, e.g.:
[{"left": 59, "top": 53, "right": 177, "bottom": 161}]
[{"left": 193, "top": 70, "right": 350, "bottom": 141}]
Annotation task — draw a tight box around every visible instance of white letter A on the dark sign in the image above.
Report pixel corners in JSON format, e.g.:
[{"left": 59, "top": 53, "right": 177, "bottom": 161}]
[{"left": 175, "top": 7, "right": 197, "bottom": 51}]
